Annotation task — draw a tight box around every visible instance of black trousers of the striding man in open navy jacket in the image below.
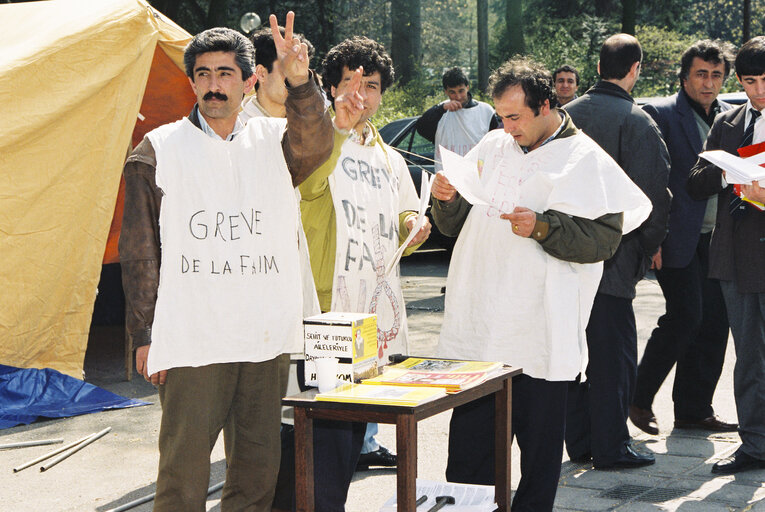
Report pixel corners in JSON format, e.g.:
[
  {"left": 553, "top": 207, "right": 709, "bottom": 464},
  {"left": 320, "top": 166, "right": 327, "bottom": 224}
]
[{"left": 632, "top": 233, "right": 728, "bottom": 421}]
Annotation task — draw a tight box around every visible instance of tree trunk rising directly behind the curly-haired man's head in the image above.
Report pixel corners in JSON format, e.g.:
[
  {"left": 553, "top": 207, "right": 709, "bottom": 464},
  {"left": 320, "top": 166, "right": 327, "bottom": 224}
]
[{"left": 390, "top": 0, "right": 422, "bottom": 85}]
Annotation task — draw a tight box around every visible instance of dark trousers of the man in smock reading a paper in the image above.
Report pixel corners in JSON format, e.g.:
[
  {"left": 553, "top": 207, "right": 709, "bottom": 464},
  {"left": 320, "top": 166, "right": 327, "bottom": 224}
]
[{"left": 446, "top": 375, "right": 569, "bottom": 512}]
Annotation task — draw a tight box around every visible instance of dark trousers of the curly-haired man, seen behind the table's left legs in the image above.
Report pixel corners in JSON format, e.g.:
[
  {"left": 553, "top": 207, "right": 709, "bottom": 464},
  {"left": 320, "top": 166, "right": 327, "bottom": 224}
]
[{"left": 274, "top": 361, "right": 367, "bottom": 512}]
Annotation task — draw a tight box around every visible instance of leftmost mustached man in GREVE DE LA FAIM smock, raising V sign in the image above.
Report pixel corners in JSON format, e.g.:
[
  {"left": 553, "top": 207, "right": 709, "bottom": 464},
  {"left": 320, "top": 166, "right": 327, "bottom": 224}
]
[{"left": 120, "top": 13, "right": 358, "bottom": 511}]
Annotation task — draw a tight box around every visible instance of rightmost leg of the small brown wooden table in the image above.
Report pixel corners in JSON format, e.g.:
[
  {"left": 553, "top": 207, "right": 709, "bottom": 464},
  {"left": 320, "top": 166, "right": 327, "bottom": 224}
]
[{"left": 494, "top": 379, "right": 513, "bottom": 512}]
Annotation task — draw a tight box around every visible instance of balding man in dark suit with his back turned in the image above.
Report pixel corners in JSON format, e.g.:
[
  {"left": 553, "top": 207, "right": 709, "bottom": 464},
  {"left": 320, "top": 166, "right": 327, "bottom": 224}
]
[{"left": 565, "top": 34, "right": 670, "bottom": 469}]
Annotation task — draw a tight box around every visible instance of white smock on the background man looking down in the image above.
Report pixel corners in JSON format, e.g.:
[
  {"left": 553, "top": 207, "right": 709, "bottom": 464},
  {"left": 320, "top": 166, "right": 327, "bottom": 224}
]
[{"left": 435, "top": 101, "right": 494, "bottom": 172}]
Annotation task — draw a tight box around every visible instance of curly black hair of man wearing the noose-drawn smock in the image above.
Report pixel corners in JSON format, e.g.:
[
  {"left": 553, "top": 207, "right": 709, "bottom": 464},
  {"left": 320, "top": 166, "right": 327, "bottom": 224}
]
[{"left": 322, "top": 36, "right": 395, "bottom": 105}]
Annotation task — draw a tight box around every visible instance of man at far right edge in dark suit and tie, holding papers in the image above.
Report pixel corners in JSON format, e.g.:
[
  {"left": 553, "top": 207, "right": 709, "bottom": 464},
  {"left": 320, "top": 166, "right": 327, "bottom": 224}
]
[{"left": 688, "top": 36, "right": 765, "bottom": 474}]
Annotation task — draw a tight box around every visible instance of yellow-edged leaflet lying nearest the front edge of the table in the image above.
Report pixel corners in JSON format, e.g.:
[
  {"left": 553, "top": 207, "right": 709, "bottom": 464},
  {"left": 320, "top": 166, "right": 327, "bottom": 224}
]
[{"left": 316, "top": 384, "right": 446, "bottom": 406}]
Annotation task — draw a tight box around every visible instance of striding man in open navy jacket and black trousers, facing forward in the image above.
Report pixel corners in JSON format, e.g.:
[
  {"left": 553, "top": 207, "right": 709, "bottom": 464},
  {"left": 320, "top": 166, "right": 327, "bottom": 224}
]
[{"left": 629, "top": 40, "right": 738, "bottom": 435}]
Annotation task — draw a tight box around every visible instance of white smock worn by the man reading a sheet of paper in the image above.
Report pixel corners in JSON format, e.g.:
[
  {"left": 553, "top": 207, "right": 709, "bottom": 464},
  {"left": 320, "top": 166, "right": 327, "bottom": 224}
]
[{"left": 439, "top": 130, "right": 651, "bottom": 381}]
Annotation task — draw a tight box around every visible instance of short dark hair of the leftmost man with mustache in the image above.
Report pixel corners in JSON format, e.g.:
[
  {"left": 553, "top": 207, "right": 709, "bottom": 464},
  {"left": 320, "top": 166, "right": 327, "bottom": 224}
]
[{"left": 183, "top": 27, "right": 255, "bottom": 80}]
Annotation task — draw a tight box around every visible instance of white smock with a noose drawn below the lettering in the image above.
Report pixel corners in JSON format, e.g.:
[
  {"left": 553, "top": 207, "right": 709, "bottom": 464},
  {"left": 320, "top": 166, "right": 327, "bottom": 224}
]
[{"left": 329, "top": 132, "right": 419, "bottom": 364}]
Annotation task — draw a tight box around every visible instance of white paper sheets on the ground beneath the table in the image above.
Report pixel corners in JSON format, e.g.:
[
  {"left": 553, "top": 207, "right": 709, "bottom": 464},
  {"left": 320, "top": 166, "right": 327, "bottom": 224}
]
[{"left": 380, "top": 478, "right": 497, "bottom": 512}]
